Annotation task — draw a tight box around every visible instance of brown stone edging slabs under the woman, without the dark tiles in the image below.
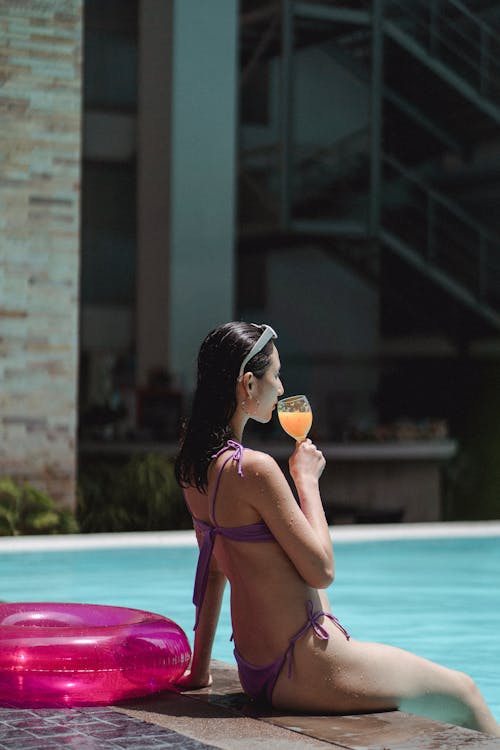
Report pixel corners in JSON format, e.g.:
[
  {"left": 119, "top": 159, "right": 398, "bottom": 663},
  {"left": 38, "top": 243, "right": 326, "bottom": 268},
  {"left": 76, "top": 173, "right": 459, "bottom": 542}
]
[{"left": 119, "top": 662, "right": 500, "bottom": 750}]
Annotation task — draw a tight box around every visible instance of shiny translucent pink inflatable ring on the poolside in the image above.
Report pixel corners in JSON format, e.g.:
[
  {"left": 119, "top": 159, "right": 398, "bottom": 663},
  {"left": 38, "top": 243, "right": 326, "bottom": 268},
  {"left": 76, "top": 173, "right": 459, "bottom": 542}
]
[{"left": 0, "top": 603, "right": 191, "bottom": 707}]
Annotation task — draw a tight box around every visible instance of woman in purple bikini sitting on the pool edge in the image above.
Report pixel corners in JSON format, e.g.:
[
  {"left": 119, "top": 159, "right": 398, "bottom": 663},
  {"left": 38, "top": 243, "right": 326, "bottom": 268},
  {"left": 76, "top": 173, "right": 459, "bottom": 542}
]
[{"left": 176, "top": 322, "right": 500, "bottom": 736}]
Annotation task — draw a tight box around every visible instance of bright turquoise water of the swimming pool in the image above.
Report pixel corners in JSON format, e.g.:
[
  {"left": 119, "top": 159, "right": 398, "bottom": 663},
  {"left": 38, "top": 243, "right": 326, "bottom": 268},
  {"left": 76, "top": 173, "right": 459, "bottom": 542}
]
[{"left": 0, "top": 537, "right": 500, "bottom": 719}]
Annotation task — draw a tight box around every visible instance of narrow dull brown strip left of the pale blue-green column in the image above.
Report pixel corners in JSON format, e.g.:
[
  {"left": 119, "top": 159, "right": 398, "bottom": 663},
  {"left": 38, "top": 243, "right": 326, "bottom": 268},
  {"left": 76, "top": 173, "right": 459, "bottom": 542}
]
[{"left": 135, "top": 0, "right": 173, "bottom": 385}]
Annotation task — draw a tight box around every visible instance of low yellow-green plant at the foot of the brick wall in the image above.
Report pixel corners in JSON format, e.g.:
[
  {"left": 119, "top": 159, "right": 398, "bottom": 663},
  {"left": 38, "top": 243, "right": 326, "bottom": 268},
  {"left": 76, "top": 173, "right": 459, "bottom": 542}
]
[{"left": 0, "top": 477, "right": 78, "bottom": 536}]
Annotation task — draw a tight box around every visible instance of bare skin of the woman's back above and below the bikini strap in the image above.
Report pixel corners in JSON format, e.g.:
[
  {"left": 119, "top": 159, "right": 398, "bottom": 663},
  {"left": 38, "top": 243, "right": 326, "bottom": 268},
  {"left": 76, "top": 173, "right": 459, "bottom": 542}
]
[{"left": 185, "top": 449, "right": 320, "bottom": 663}]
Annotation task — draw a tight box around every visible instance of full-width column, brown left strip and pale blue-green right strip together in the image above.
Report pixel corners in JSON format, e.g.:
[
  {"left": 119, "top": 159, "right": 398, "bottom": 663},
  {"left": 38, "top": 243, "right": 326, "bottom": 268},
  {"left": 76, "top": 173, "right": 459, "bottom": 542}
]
[{"left": 137, "top": 0, "right": 238, "bottom": 391}]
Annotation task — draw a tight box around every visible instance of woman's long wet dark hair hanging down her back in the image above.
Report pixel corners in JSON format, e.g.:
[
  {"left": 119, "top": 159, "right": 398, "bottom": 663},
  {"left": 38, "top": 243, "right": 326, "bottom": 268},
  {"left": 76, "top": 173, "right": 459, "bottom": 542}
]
[{"left": 175, "top": 321, "right": 273, "bottom": 492}]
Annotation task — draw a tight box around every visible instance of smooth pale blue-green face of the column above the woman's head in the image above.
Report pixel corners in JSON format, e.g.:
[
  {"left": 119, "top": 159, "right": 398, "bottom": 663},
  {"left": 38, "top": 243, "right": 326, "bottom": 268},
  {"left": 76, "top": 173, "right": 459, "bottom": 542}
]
[{"left": 170, "top": 0, "right": 238, "bottom": 389}]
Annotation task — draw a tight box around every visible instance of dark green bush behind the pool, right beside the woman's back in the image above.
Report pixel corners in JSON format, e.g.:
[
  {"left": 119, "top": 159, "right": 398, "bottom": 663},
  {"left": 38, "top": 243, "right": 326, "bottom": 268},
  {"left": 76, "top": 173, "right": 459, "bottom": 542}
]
[{"left": 77, "top": 453, "right": 192, "bottom": 532}]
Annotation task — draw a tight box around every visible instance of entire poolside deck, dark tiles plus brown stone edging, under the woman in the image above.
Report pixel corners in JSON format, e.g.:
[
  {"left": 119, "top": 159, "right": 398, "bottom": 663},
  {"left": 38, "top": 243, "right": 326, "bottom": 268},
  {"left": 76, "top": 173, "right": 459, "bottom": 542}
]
[{"left": 0, "top": 662, "right": 500, "bottom": 750}]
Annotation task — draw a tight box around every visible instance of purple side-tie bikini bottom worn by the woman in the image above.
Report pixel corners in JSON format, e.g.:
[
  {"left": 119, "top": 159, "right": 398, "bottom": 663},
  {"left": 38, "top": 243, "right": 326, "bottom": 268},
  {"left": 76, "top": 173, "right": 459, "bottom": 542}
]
[{"left": 234, "top": 600, "right": 350, "bottom": 703}]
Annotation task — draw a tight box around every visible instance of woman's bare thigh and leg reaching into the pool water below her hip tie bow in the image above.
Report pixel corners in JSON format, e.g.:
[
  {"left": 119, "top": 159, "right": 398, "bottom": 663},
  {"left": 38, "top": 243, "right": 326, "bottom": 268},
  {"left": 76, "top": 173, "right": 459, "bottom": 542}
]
[{"left": 273, "top": 629, "right": 500, "bottom": 736}]
